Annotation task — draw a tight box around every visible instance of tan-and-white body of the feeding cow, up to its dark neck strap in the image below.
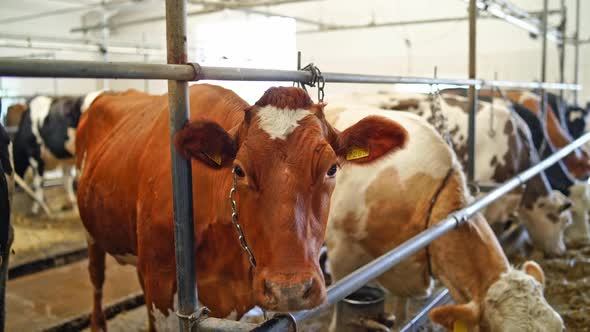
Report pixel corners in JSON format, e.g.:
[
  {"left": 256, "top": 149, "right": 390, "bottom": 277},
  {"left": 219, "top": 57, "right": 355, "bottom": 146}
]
[{"left": 326, "top": 106, "right": 461, "bottom": 296}]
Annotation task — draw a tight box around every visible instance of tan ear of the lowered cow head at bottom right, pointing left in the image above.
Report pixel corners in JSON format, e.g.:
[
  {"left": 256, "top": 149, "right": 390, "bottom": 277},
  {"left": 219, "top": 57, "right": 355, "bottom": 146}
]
[{"left": 429, "top": 303, "right": 479, "bottom": 332}]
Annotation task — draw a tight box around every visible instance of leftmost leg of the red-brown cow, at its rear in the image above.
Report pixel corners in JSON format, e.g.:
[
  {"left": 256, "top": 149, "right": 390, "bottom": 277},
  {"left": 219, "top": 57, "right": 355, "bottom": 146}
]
[{"left": 88, "top": 240, "right": 107, "bottom": 331}]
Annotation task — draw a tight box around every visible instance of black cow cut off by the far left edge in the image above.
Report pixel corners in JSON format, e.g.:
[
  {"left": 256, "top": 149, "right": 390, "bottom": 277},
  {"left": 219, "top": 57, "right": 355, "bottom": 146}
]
[{"left": 0, "top": 124, "right": 14, "bottom": 331}]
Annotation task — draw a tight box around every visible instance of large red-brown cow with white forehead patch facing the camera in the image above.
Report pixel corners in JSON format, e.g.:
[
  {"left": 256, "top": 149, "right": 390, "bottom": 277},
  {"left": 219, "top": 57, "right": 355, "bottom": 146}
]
[{"left": 77, "top": 84, "right": 406, "bottom": 330}]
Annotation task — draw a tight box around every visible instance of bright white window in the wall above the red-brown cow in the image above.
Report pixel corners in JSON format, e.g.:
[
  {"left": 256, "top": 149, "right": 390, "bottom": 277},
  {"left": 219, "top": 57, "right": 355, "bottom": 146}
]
[{"left": 194, "top": 16, "right": 297, "bottom": 103}]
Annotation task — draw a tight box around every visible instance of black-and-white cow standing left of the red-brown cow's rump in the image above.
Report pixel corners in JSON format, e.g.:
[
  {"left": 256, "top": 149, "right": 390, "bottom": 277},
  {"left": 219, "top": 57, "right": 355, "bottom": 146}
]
[{"left": 13, "top": 91, "right": 102, "bottom": 213}]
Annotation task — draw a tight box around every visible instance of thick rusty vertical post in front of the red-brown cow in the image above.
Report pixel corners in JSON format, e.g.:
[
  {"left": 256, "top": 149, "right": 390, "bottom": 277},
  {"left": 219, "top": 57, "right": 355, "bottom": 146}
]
[{"left": 166, "top": 0, "right": 197, "bottom": 332}]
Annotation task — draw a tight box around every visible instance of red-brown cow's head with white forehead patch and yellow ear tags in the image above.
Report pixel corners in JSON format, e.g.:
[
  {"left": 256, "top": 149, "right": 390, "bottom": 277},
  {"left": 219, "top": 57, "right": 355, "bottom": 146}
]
[{"left": 175, "top": 87, "right": 407, "bottom": 311}]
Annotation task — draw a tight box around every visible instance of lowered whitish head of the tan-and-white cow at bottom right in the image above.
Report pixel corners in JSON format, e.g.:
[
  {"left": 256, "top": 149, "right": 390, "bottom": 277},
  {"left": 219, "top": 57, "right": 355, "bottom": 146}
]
[{"left": 430, "top": 261, "right": 565, "bottom": 332}]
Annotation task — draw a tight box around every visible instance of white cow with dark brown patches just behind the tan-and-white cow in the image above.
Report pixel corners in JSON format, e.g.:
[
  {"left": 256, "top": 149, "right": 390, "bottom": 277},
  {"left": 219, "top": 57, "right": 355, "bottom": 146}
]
[{"left": 336, "top": 93, "right": 571, "bottom": 255}]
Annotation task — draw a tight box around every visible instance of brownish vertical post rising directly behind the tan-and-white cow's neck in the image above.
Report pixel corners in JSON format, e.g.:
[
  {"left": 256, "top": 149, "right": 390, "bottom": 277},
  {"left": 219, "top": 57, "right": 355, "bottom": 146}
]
[{"left": 467, "top": 0, "right": 477, "bottom": 182}]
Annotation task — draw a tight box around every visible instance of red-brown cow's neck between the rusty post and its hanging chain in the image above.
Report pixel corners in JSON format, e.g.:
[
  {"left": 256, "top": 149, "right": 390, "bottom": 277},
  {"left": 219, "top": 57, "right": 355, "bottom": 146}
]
[{"left": 193, "top": 168, "right": 255, "bottom": 317}]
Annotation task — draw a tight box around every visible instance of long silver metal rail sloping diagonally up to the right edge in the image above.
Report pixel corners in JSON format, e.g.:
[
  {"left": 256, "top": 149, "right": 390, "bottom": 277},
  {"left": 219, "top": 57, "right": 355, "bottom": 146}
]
[{"left": 276, "top": 133, "right": 590, "bottom": 322}]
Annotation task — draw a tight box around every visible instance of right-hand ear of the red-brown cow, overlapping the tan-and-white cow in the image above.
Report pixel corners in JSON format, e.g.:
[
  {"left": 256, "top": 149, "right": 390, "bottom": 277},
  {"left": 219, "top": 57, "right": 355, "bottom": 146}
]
[{"left": 334, "top": 116, "right": 408, "bottom": 164}]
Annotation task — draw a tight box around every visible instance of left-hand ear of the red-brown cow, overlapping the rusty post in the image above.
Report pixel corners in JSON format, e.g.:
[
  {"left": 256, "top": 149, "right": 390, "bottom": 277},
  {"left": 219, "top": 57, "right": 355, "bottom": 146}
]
[{"left": 174, "top": 121, "right": 237, "bottom": 169}]
